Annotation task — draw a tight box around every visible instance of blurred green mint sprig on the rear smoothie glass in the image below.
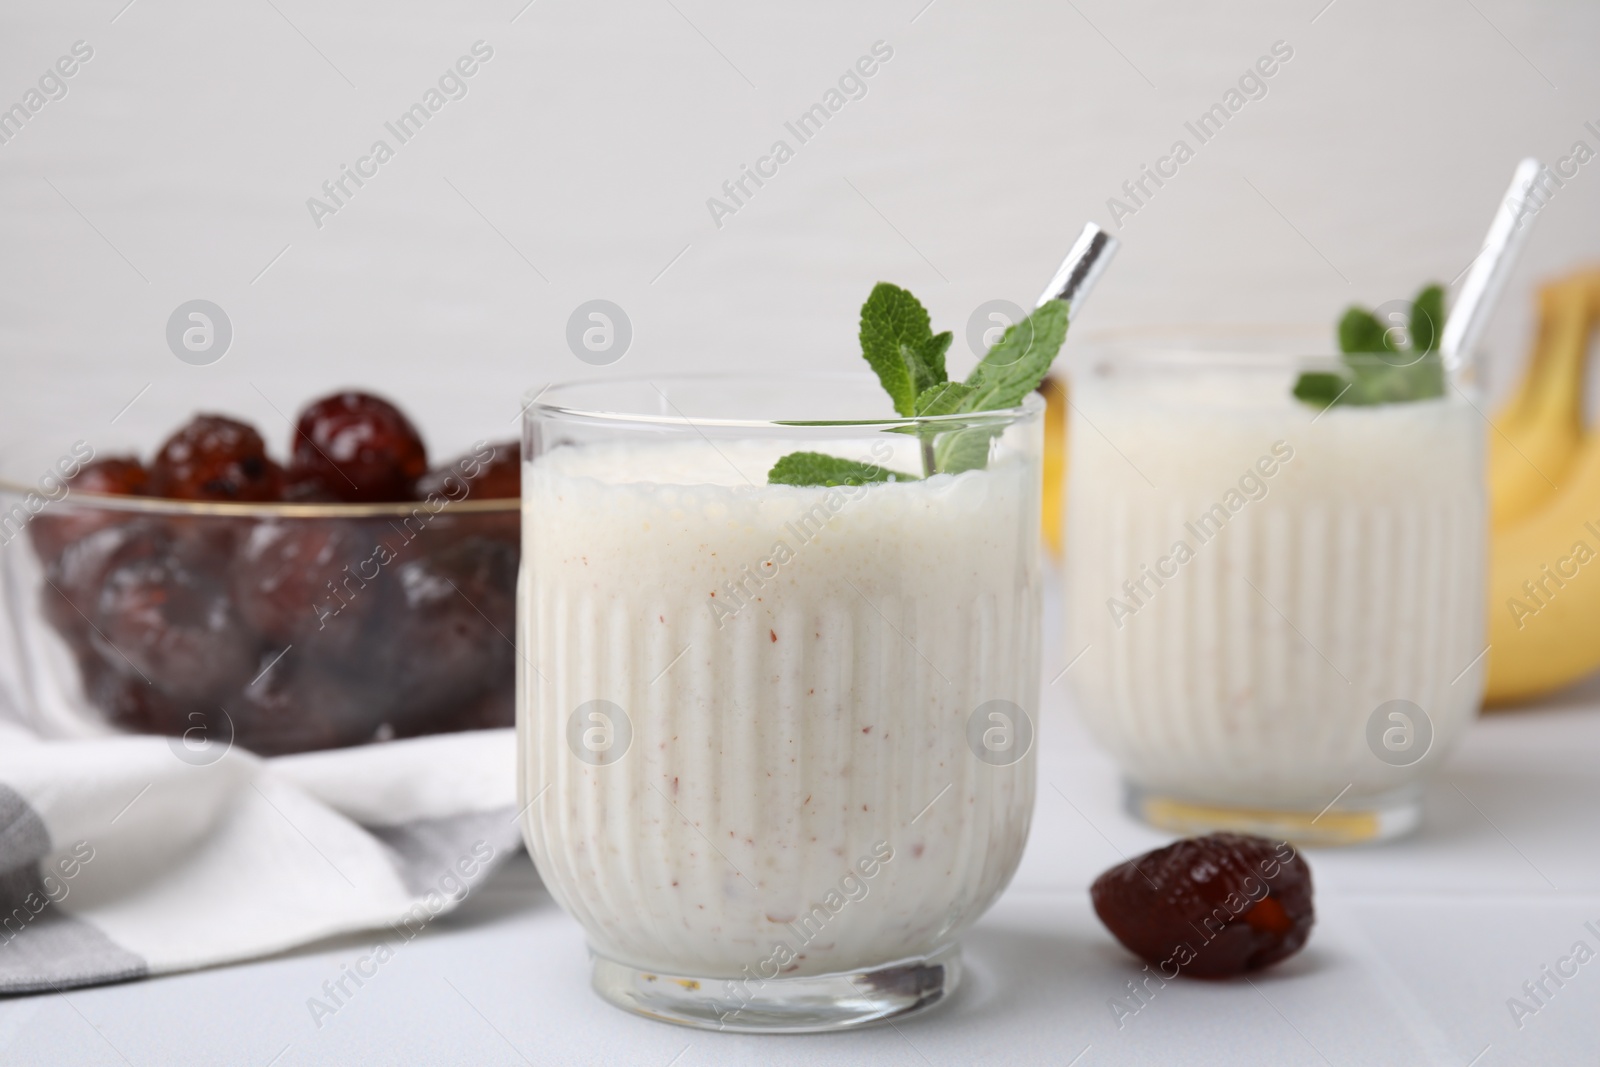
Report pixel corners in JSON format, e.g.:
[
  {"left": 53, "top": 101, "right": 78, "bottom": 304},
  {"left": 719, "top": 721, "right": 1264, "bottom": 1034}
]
[{"left": 1294, "top": 285, "right": 1445, "bottom": 408}]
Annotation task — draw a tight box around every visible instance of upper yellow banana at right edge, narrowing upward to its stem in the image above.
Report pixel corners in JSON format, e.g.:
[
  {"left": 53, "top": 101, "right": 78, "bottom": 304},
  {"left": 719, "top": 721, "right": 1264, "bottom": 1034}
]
[{"left": 1488, "top": 272, "right": 1600, "bottom": 530}]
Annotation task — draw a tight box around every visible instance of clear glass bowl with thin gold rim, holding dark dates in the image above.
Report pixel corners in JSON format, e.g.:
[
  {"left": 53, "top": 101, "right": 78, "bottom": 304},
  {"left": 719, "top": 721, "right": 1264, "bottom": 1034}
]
[{"left": 0, "top": 474, "right": 520, "bottom": 755}]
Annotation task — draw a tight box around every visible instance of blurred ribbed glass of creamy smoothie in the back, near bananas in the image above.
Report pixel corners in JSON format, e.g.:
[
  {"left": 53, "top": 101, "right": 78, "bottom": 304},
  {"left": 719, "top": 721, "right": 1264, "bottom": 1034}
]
[{"left": 1066, "top": 330, "right": 1488, "bottom": 843}]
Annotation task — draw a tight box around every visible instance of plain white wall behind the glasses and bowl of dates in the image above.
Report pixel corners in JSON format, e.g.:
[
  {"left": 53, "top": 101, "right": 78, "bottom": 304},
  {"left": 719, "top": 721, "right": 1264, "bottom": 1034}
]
[{"left": 0, "top": 0, "right": 1600, "bottom": 466}]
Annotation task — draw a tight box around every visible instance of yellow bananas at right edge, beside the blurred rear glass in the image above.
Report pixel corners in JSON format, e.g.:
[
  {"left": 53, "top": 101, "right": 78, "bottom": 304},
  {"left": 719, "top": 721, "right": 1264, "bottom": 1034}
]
[{"left": 1485, "top": 272, "right": 1600, "bottom": 704}]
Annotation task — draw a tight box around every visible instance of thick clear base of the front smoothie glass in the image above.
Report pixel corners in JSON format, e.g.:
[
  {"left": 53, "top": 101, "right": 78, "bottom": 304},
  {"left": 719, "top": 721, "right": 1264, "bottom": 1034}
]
[{"left": 594, "top": 944, "right": 962, "bottom": 1033}]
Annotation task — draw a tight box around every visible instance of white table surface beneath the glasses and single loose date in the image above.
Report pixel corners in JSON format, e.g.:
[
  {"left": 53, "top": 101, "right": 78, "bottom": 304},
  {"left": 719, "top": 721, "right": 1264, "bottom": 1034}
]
[{"left": 0, "top": 585, "right": 1600, "bottom": 1067}]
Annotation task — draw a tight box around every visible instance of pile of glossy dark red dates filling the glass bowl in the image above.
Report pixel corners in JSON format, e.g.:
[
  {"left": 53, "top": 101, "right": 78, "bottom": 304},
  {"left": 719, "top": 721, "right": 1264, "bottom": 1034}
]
[{"left": 29, "top": 392, "right": 520, "bottom": 755}]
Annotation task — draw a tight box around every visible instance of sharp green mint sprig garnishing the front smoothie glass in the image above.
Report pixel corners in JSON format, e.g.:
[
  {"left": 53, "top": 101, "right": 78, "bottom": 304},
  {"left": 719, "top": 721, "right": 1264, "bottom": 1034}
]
[{"left": 766, "top": 282, "right": 1067, "bottom": 486}]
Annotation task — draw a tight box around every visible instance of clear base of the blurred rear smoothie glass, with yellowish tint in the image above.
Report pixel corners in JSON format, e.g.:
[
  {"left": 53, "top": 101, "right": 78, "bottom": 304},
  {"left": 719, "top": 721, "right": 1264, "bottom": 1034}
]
[{"left": 1123, "top": 782, "right": 1422, "bottom": 845}]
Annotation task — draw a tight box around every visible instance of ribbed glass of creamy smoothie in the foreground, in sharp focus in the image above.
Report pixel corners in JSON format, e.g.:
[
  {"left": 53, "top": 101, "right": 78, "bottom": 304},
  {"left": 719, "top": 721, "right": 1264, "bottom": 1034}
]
[{"left": 517, "top": 374, "right": 1043, "bottom": 1032}]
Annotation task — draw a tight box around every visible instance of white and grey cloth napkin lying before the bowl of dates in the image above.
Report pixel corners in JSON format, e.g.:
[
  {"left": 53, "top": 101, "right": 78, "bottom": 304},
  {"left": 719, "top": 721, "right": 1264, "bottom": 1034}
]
[{"left": 0, "top": 721, "right": 520, "bottom": 993}]
